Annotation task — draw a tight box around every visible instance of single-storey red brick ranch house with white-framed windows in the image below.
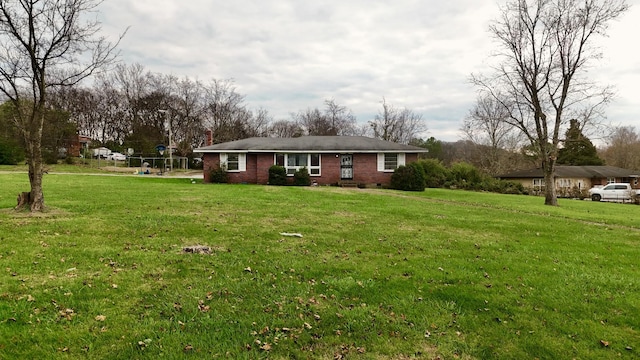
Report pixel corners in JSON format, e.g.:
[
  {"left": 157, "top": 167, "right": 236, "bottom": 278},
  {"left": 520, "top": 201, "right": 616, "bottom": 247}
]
[{"left": 194, "top": 133, "right": 427, "bottom": 186}]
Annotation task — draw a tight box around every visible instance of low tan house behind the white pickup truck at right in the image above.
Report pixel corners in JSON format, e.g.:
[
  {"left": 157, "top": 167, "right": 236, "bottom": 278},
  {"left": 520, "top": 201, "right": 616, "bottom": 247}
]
[{"left": 498, "top": 166, "right": 640, "bottom": 195}]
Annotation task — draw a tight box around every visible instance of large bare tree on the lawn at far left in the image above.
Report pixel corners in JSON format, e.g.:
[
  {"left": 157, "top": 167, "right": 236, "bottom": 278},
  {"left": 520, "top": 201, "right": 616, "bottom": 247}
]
[{"left": 0, "top": 0, "right": 122, "bottom": 211}]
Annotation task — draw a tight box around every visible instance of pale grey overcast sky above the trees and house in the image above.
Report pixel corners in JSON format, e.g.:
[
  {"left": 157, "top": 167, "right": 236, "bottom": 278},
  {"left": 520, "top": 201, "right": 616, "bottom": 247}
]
[{"left": 99, "top": 0, "right": 640, "bottom": 141}]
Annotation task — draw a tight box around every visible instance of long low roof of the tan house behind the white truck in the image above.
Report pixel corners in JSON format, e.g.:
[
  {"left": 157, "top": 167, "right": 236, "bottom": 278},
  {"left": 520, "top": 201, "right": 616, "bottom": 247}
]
[{"left": 499, "top": 166, "right": 638, "bottom": 179}]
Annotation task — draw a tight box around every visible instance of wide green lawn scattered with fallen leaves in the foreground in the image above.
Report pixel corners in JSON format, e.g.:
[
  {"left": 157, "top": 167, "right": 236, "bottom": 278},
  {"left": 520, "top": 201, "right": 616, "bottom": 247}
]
[{"left": 0, "top": 173, "right": 640, "bottom": 359}]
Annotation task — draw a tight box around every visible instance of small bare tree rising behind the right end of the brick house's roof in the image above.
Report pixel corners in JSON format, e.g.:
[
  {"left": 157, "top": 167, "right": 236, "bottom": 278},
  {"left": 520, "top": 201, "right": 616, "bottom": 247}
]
[{"left": 369, "top": 98, "right": 427, "bottom": 144}]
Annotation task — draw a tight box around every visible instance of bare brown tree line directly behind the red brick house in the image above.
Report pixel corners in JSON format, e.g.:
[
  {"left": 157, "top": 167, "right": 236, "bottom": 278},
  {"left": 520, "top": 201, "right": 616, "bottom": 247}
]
[{"left": 0, "top": 64, "right": 426, "bottom": 165}]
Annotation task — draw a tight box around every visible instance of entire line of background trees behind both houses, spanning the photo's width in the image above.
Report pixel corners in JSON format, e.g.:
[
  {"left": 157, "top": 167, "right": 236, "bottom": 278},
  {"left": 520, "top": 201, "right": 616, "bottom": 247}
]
[{"left": 0, "top": 60, "right": 640, "bottom": 176}]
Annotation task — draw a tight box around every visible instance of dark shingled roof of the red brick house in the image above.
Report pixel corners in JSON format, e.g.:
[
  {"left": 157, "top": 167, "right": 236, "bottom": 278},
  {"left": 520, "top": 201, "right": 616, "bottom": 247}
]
[{"left": 194, "top": 136, "right": 428, "bottom": 153}]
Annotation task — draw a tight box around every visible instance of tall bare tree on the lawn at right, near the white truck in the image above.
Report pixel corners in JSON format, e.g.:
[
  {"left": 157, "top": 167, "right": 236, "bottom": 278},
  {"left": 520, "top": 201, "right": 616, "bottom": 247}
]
[{"left": 473, "top": 0, "right": 628, "bottom": 206}]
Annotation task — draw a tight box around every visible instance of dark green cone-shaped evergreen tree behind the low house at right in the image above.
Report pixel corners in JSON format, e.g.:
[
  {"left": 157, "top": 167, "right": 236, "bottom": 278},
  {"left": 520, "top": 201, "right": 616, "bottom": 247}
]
[{"left": 557, "top": 119, "right": 604, "bottom": 166}]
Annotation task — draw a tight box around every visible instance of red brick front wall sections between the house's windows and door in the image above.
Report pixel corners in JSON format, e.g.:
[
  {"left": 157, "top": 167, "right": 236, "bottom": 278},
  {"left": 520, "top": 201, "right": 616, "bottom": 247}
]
[{"left": 203, "top": 153, "right": 418, "bottom": 186}]
